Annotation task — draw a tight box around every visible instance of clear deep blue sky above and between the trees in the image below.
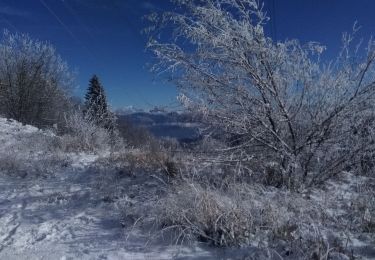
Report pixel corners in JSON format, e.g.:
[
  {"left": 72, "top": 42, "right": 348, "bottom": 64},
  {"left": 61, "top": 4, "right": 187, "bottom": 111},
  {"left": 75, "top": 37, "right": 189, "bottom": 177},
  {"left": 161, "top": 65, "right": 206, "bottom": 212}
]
[{"left": 0, "top": 0, "right": 375, "bottom": 109}]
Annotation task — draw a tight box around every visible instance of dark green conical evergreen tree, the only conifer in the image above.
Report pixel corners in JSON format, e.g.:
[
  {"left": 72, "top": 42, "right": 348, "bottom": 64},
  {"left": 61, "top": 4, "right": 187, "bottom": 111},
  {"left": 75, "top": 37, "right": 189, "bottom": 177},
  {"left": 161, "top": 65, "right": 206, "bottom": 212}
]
[{"left": 84, "top": 75, "right": 115, "bottom": 132}]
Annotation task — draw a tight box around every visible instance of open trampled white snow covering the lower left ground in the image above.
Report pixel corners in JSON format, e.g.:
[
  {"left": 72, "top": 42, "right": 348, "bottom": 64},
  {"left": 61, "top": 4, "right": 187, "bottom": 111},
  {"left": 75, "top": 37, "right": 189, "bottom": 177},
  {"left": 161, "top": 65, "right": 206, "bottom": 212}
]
[{"left": 0, "top": 118, "right": 216, "bottom": 260}]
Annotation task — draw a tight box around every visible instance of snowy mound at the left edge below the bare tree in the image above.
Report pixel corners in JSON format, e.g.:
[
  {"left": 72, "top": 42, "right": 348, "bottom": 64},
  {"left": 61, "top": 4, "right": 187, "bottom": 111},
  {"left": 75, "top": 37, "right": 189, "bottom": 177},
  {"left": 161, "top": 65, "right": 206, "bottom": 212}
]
[{"left": 0, "top": 121, "right": 70, "bottom": 177}]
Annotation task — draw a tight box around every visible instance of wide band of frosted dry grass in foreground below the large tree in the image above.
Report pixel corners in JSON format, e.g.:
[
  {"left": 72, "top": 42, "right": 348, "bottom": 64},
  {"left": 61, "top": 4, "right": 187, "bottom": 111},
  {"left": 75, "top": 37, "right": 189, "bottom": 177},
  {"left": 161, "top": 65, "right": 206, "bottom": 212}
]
[{"left": 141, "top": 180, "right": 358, "bottom": 259}]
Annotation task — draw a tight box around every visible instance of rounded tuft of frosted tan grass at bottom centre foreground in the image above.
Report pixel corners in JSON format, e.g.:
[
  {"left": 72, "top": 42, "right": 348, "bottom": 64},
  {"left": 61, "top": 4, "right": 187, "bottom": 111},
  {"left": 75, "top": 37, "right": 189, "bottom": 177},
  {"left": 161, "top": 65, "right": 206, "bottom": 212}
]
[{"left": 157, "top": 184, "right": 254, "bottom": 246}]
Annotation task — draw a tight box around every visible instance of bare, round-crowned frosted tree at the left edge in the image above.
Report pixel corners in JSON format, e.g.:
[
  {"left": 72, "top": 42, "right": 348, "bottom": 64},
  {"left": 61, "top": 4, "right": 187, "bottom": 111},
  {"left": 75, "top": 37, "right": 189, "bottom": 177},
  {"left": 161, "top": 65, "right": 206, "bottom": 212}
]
[{"left": 0, "top": 31, "right": 73, "bottom": 127}]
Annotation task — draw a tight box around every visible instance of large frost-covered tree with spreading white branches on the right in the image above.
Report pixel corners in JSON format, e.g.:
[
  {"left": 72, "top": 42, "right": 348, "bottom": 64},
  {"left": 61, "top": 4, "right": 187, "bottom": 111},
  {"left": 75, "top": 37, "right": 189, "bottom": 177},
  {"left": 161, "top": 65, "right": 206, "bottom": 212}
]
[{"left": 148, "top": 0, "right": 375, "bottom": 188}]
